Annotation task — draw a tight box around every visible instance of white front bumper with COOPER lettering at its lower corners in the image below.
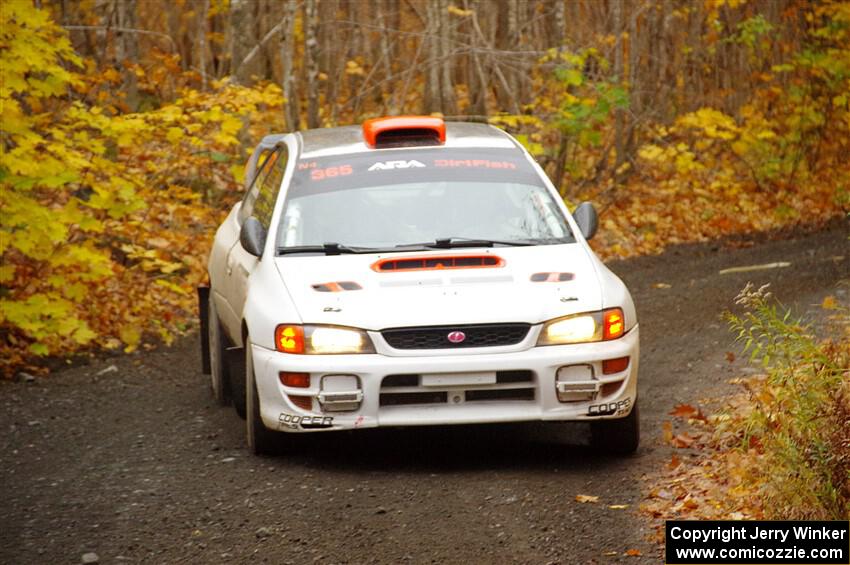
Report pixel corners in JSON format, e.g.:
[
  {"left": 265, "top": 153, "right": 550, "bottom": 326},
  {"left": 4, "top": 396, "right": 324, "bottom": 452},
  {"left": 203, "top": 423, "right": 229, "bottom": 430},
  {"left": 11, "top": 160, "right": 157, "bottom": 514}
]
[{"left": 252, "top": 326, "right": 639, "bottom": 432}]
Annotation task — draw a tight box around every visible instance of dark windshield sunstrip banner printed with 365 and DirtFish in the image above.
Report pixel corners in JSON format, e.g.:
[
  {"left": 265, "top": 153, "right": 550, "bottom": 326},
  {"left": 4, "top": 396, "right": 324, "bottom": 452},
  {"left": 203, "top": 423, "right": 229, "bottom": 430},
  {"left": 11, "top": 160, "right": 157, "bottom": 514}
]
[{"left": 290, "top": 148, "right": 543, "bottom": 196}]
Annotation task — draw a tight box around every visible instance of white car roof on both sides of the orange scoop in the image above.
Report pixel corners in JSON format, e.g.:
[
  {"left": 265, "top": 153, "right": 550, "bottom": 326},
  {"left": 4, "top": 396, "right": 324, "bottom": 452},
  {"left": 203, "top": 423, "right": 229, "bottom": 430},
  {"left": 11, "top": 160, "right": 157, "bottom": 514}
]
[{"left": 296, "top": 122, "right": 520, "bottom": 158}]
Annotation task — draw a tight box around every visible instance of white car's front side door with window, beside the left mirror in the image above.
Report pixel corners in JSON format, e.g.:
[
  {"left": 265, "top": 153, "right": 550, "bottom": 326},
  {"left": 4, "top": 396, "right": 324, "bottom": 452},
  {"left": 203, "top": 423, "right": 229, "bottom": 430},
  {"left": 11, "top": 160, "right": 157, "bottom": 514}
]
[{"left": 225, "top": 146, "right": 287, "bottom": 341}]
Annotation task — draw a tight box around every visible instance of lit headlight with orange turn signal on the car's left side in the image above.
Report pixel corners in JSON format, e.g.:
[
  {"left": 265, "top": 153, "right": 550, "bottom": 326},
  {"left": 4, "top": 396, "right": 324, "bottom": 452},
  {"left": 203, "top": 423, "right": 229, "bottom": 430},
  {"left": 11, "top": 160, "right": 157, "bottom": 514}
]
[{"left": 274, "top": 324, "right": 375, "bottom": 355}]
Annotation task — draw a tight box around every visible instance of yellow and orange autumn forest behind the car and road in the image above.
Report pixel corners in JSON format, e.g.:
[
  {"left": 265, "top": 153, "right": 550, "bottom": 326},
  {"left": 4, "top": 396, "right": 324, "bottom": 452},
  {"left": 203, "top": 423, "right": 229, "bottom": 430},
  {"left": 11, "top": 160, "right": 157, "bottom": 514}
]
[{"left": 0, "top": 0, "right": 850, "bottom": 375}]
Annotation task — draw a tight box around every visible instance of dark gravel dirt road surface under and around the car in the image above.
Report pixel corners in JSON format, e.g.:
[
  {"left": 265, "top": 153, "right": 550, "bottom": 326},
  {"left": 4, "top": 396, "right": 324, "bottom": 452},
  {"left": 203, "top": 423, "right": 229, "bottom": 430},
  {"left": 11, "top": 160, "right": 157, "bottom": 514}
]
[{"left": 0, "top": 222, "right": 850, "bottom": 564}]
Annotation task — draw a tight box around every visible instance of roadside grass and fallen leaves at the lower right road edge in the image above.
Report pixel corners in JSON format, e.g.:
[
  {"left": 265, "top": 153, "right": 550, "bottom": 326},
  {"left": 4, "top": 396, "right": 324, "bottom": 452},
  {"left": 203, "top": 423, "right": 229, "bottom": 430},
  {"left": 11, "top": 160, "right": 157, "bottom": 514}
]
[{"left": 641, "top": 285, "right": 850, "bottom": 541}]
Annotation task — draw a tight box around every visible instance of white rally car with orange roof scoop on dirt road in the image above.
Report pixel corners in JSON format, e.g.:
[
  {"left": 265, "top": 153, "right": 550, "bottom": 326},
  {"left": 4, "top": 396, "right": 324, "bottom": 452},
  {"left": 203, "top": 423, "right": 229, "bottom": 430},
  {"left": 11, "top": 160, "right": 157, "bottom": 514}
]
[{"left": 199, "top": 116, "right": 639, "bottom": 454}]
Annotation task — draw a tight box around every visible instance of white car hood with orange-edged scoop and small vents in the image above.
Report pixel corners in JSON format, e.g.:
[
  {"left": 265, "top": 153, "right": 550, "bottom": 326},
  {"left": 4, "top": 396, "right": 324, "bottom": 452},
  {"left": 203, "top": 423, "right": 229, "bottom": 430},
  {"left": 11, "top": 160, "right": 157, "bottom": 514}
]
[{"left": 275, "top": 244, "right": 602, "bottom": 330}]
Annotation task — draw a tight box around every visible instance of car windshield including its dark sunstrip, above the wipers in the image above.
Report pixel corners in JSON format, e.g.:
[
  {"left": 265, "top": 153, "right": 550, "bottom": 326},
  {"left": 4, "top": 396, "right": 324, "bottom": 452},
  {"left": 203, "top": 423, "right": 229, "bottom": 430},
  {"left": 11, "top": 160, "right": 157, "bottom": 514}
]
[{"left": 277, "top": 150, "right": 574, "bottom": 252}]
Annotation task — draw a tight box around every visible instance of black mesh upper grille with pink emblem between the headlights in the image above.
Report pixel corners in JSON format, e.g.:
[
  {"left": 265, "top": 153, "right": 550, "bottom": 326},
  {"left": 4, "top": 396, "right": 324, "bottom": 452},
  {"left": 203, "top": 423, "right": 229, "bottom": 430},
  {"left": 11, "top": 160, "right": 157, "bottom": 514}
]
[{"left": 381, "top": 324, "right": 531, "bottom": 349}]
